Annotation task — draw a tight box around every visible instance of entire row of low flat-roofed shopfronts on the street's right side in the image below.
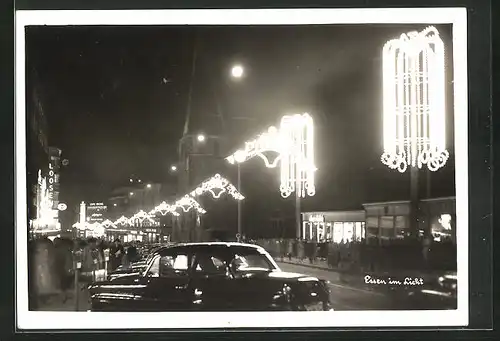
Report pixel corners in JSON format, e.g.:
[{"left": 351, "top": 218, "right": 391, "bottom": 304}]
[{"left": 301, "top": 197, "right": 456, "bottom": 244}]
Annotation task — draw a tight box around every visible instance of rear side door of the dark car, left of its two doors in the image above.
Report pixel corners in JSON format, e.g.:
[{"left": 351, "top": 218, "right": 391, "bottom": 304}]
[{"left": 146, "top": 253, "right": 192, "bottom": 311}]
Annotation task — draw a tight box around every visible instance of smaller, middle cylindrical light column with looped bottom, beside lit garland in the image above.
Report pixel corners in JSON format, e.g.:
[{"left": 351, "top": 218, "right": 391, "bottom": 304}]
[{"left": 280, "top": 113, "right": 316, "bottom": 198}]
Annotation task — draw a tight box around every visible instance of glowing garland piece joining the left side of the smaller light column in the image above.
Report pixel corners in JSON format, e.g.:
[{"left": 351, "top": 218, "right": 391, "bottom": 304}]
[{"left": 226, "top": 126, "right": 283, "bottom": 168}]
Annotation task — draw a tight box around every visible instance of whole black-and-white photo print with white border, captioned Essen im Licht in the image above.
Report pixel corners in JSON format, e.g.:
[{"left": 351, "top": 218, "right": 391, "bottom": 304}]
[{"left": 15, "top": 8, "right": 469, "bottom": 329}]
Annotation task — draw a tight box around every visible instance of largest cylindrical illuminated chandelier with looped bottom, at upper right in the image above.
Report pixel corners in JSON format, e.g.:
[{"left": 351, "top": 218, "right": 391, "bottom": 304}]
[{"left": 381, "top": 27, "right": 449, "bottom": 173}]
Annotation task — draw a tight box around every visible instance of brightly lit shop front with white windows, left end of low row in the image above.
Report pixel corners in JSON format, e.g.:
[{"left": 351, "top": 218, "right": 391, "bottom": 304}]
[{"left": 301, "top": 211, "right": 365, "bottom": 243}]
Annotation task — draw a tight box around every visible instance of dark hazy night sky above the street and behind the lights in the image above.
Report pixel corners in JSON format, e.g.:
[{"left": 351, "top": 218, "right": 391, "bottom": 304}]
[{"left": 26, "top": 25, "right": 454, "bottom": 210}]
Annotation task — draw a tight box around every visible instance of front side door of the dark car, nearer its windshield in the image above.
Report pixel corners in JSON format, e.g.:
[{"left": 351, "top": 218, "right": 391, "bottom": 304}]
[{"left": 189, "top": 251, "right": 234, "bottom": 311}]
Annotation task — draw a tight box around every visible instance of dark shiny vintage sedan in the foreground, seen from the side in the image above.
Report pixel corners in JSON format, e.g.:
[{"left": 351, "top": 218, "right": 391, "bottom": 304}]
[{"left": 89, "top": 243, "right": 332, "bottom": 311}]
